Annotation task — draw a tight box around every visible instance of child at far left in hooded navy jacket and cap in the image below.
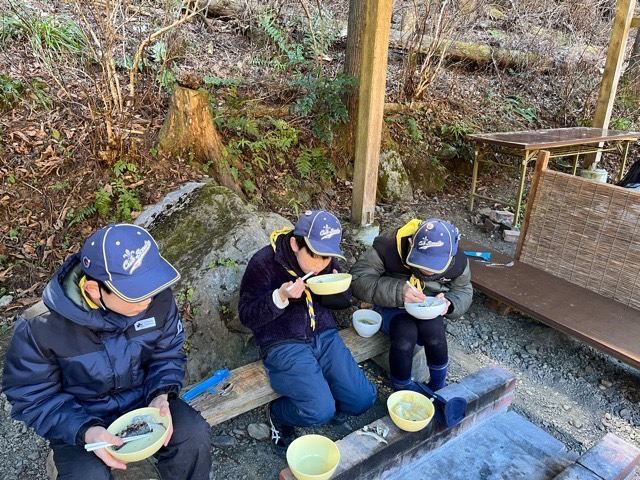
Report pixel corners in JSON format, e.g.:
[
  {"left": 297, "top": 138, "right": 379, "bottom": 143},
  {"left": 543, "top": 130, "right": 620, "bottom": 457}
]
[{"left": 2, "top": 224, "right": 211, "bottom": 480}]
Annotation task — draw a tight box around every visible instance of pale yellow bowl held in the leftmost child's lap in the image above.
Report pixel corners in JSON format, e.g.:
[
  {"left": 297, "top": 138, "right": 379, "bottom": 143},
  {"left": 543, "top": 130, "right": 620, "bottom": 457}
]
[{"left": 107, "top": 407, "right": 171, "bottom": 463}]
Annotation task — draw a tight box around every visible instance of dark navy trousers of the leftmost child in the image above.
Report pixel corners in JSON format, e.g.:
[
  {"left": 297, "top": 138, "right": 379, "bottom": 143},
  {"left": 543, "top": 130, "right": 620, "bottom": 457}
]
[{"left": 51, "top": 398, "right": 211, "bottom": 480}]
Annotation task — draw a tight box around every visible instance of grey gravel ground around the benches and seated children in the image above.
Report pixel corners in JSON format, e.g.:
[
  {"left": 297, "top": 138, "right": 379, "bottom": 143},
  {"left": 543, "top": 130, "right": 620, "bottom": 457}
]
[{"left": 0, "top": 186, "right": 640, "bottom": 480}]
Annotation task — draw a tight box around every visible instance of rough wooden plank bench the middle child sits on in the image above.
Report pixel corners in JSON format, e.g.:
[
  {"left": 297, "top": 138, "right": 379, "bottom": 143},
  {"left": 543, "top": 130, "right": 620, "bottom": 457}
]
[{"left": 191, "top": 328, "right": 389, "bottom": 425}]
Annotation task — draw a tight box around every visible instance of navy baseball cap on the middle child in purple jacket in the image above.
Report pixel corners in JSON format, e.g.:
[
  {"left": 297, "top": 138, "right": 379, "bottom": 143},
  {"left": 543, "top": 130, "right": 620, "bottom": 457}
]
[{"left": 293, "top": 210, "right": 344, "bottom": 259}]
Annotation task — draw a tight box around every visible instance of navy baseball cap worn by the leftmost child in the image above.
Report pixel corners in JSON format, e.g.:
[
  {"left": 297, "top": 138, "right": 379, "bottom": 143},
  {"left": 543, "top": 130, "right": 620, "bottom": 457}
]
[{"left": 80, "top": 223, "right": 180, "bottom": 303}]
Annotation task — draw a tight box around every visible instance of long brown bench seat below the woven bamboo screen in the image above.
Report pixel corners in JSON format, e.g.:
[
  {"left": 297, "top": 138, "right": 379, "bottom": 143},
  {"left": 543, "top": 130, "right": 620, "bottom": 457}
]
[{"left": 462, "top": 241, "right": 640, "bottom": 368}]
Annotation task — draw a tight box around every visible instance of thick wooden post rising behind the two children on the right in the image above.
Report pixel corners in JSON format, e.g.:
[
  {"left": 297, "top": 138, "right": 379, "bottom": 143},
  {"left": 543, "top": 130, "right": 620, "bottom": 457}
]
[{"left": 351, "top": 0, "right": 393, "bottom": 225}]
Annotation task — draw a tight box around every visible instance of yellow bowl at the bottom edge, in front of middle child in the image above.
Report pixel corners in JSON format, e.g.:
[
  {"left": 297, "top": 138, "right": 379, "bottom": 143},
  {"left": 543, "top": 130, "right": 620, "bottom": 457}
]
[{"left": 287, "top": 435, "right": 340, "bottom": 480}]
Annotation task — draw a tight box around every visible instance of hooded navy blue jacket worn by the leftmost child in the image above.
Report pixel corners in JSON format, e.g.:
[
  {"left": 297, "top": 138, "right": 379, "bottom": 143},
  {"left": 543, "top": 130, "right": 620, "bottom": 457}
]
[{"left": 2, "top": 255, "right": 186, "bottom": 444}]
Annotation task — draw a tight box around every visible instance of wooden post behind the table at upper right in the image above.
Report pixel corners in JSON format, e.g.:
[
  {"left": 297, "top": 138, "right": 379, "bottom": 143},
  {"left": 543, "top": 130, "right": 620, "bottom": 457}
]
[{"left": 584, "top": 0, "right": 636, "bottom": 168}]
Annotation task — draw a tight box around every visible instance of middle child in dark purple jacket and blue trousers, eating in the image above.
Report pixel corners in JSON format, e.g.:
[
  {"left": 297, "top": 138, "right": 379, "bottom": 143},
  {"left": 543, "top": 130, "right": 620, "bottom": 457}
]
[{"left": 239, "top": 210, "right": 376, "bottom": 449}]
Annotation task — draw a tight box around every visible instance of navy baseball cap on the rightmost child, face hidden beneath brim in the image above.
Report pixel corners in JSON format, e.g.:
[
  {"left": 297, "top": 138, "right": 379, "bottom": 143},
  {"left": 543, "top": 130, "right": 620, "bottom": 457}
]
[{"left": 406, "top": 218, "right": 460, "bottom": 273}]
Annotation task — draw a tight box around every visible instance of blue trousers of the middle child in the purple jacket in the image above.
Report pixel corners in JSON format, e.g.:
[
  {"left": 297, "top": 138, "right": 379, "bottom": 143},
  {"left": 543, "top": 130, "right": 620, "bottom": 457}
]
[{"left": 264, "top": 329, "right": 376, "bottom": 427}]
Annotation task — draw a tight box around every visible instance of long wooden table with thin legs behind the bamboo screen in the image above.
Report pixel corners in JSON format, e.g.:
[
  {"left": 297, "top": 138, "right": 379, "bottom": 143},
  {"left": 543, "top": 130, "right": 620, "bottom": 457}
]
[{"left": 469, "top": 127, "right": 640, "bottom": 225}]
